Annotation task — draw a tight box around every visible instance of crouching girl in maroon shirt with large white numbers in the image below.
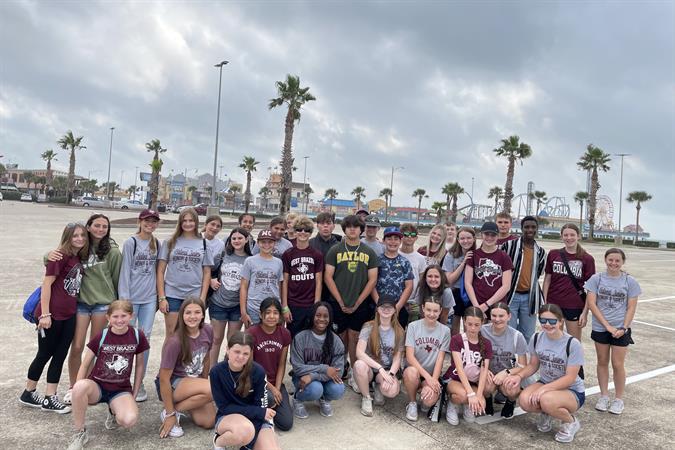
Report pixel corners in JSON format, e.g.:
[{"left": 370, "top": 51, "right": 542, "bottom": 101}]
[{"left": 443, "top": 306, "right": 494, "bottom": 425}]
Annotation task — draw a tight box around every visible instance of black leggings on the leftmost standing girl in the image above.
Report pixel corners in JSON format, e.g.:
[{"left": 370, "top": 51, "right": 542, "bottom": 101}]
[{"left": 28, "top": 316, "right": 75, "bottom": 384}]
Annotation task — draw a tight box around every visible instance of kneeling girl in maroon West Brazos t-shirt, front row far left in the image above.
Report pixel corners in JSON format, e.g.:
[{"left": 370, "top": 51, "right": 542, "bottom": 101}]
[{"left": 68, "top": 300, "right": 150, "bottom": 450}]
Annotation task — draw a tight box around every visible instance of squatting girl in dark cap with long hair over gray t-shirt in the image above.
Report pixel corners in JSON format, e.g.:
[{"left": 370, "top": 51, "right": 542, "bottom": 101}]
[{"left": 354, "top": 294, "right": 405, "bottom": 416}]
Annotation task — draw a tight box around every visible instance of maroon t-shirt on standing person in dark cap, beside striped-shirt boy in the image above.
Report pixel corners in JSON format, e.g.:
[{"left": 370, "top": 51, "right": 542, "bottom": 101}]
[{"left": 467, "top": 248, "right": 513, "bottom": 304}]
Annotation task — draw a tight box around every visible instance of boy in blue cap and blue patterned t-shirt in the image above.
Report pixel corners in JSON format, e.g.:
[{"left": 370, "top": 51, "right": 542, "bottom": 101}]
[{"left": 372, "top": 227, "right": 414, "bottom": 328}]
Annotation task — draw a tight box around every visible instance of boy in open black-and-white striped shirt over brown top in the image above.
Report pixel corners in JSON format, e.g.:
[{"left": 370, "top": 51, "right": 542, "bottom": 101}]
[{"left": 502, "top": 216, "right": 546, "bottom": 342}]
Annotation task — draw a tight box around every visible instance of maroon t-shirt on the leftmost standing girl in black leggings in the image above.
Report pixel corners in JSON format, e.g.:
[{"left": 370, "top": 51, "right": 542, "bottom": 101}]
[{"left": 35, "top": 256, "right": 84, "bottom": 320}]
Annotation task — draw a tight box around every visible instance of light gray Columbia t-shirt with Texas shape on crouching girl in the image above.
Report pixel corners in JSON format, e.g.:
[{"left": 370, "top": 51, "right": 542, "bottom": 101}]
[{"left": 405, "top": 319, "right": 450, "bottom": 373}]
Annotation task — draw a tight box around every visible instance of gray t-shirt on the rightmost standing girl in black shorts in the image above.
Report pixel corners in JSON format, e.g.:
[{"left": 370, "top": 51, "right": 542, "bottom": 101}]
[{"left": 584, "top": 272, "right": 642, "bottom": 331}]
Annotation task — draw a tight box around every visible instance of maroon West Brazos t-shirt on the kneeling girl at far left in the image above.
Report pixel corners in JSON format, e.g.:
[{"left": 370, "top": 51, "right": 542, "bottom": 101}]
[{"left": 87, "top": 327, "right": 150, "bottom": 392}]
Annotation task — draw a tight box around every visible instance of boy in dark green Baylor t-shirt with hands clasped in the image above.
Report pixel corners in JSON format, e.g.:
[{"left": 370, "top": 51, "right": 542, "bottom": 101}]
[{"left": 324, "top": 215, "right": 379, "bottom": 376}]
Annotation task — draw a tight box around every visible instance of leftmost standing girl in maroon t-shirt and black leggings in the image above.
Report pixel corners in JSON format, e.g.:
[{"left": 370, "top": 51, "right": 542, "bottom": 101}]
[{"left": 19, "top": 223, "right": 89, "bottom": 413}]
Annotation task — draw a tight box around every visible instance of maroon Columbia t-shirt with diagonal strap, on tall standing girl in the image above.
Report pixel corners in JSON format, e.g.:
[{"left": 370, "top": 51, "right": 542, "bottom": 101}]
[{"left": 544, "top": 249, "right": 595, "bottom": 309}]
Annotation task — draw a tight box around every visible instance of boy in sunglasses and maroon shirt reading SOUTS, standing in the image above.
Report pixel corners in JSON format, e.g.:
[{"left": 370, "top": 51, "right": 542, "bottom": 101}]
[{"left": 281, "top": 216, "right": 323, "bottom": 337}]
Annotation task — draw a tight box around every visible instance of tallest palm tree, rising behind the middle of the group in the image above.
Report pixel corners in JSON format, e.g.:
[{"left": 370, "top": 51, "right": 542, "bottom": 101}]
[{"left": 268, "top": 74, "right": 316, "bottom": 214}]
